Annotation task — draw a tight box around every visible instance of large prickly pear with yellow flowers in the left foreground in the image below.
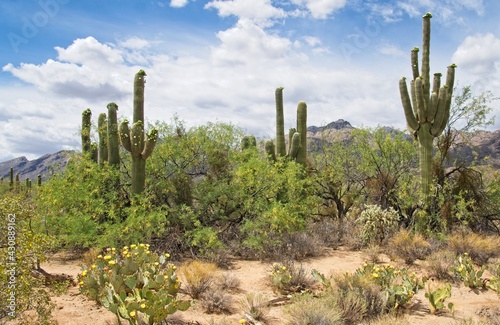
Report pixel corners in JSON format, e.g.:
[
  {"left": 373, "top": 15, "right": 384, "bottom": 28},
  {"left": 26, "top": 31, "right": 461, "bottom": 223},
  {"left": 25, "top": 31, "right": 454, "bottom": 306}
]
[{"left": 79, "top": 244, "right": 192, "bottom": 324}]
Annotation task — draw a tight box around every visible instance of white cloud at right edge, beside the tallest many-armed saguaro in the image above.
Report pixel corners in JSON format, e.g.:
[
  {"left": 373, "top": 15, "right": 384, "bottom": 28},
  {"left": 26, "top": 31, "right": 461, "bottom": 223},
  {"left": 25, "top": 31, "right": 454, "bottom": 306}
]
[{"left": 452, "top": 33, "right": 500, "bottom": 75}]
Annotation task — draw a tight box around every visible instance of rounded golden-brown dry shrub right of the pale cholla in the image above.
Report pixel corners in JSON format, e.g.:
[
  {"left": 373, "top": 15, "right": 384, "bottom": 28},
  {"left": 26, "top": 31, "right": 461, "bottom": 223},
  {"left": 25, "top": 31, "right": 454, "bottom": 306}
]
[{"left": 387, "top": 229, "right": 430, "bottom": 265}]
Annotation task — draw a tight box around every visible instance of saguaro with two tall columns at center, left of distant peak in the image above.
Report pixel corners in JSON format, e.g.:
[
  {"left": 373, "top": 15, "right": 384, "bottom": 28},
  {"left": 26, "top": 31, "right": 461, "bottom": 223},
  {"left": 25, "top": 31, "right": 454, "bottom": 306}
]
[{"left": 265, "top": 87, "right": 307, "bottom": 166}]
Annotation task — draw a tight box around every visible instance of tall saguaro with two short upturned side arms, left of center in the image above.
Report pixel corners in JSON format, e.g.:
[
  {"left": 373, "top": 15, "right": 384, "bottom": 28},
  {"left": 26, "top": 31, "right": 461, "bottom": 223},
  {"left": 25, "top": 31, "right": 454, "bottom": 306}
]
[{"left": 120, "top": 70, "right": 158, "bottom": 194}]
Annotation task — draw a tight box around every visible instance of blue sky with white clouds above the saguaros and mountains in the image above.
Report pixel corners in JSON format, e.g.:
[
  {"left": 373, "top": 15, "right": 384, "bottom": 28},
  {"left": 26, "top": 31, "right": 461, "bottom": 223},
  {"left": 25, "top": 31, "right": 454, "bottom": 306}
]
[{"left": 0, "top": 0, "right": 500, "bottom": 161}]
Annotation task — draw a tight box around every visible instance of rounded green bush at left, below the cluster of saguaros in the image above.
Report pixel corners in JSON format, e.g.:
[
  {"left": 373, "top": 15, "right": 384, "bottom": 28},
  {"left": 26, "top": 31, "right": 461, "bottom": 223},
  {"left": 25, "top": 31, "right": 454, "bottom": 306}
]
[{"left": 36, "top": 155, "right": 127, "bottom": 247}]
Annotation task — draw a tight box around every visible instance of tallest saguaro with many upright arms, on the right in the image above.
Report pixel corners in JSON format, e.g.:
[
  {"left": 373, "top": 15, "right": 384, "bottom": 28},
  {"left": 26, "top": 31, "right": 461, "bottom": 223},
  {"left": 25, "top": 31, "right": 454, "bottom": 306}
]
[{"left": 399, "top": 13, "right": 456, "bottom": 198}]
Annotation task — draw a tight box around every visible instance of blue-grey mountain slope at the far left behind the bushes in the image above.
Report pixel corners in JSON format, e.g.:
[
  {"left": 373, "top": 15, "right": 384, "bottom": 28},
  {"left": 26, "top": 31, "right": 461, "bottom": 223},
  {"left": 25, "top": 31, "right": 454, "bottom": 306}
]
[{"left": 0, "top": 150, "right": 73, "bottom": 182}]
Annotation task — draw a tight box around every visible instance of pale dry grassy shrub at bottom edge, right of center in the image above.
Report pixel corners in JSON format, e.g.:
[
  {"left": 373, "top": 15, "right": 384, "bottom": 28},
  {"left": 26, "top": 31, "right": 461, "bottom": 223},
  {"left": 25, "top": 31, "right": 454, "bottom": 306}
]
[{"left": 285, "top": 294, "right": 344, "bottom": 325}]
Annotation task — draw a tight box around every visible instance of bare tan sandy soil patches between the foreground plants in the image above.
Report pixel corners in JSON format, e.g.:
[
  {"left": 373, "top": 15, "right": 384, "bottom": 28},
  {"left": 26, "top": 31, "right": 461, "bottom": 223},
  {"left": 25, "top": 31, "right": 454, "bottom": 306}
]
[{"left": 9, "top": 250, "right": 500, "bottom": 325}]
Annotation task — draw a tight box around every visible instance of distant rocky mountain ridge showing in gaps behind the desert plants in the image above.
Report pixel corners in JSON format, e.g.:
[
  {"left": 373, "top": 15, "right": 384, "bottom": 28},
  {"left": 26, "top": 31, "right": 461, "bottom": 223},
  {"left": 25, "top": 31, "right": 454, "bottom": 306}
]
[{"left": 0, "top": 119, "right": 500, "bottom": 181}]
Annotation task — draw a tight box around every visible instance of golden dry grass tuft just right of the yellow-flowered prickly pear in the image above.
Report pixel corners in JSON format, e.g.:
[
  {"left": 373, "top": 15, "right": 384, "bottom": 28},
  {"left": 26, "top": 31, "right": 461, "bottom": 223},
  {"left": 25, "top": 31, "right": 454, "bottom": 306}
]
[{"left": 179, "top": 260, "right": 217, "bottom": 299}]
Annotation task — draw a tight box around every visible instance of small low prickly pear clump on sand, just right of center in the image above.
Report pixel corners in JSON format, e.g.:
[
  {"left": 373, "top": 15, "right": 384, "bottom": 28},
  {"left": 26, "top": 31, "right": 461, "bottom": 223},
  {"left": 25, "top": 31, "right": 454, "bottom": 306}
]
[{"left": 270, "top": 261, "right": 315, "bottom": 294}]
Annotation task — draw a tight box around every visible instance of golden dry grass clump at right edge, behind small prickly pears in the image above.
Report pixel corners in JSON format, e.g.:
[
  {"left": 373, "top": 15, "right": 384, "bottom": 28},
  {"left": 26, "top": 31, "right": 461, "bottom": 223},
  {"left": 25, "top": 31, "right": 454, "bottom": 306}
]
[{"left": 448, "top": 232, "right": 500, "bottom": 266}]
